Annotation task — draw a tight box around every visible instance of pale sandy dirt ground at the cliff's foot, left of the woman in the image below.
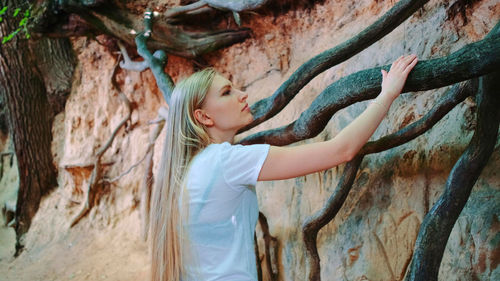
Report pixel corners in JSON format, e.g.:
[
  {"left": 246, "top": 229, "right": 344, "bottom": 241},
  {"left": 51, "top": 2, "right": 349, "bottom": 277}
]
[{"left": 0, "top": 205, "right": 149, "bottom": 281}]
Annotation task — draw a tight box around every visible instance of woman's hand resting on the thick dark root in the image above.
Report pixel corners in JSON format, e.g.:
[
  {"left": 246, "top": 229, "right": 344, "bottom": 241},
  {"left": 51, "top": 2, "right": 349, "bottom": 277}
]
[{"left": 380, "top": 55, "right": 418, "bottom": 100}]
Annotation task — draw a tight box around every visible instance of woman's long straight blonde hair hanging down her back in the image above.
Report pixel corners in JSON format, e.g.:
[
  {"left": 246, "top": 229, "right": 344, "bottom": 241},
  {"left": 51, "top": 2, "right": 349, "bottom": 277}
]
[{"left": 150, "top": 68, "right": 216, "bottom": 281}]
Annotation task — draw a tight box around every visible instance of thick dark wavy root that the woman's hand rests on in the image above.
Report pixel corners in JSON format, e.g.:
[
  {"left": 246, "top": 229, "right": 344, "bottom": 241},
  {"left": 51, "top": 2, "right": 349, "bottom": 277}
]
[{"left": 240, "top": 35, "right": 500, "bottom": 145}]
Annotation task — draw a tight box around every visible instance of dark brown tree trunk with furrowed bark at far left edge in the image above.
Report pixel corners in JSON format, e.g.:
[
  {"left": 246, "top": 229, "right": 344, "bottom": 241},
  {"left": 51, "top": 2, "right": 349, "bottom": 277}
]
[{"left": 0, "top": 0, "right": 57, "bottom": 255}]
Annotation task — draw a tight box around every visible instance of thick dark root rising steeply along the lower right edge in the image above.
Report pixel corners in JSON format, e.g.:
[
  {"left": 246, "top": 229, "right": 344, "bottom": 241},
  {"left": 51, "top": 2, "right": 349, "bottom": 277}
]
[{"left": 405, "top": 69, "right": 500, "bottom": 281}]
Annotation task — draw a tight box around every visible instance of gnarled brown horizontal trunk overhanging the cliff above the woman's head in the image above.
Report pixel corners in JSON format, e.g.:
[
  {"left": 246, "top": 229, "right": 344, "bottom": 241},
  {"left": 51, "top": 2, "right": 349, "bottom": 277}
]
[{"left": 32, "top": 0, "right": 251, "bottom": 58}]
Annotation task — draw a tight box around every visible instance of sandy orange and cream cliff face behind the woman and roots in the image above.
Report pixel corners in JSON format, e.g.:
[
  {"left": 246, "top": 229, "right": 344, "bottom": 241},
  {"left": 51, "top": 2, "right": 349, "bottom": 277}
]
[{"left": 1, "top": 0, "right": 500, "bottom": 280}]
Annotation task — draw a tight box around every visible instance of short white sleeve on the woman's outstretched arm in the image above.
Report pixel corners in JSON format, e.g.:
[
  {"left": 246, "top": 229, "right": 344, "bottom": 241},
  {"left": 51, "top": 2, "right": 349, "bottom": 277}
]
[{"left": 221, "top": 143, "right": 270, "bottom": 190}]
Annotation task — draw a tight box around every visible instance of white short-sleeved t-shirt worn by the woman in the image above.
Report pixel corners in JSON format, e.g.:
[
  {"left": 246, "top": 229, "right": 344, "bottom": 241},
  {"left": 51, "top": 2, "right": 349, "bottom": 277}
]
[{"left": 185, "top": 142, "right": 269, "bottom": 281}]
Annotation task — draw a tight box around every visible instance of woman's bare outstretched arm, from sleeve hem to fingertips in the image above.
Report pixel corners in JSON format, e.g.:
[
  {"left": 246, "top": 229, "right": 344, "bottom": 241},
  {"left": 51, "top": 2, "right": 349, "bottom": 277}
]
[{"left": 258, "top": 55, "right": 417, "bottom": 181}]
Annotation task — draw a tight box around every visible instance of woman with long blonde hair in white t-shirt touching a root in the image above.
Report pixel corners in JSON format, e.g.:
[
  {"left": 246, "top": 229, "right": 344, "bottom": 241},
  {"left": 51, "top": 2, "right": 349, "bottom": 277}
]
[{"left": 151, "top": 55, "right": 417, "bottom": 281}]
